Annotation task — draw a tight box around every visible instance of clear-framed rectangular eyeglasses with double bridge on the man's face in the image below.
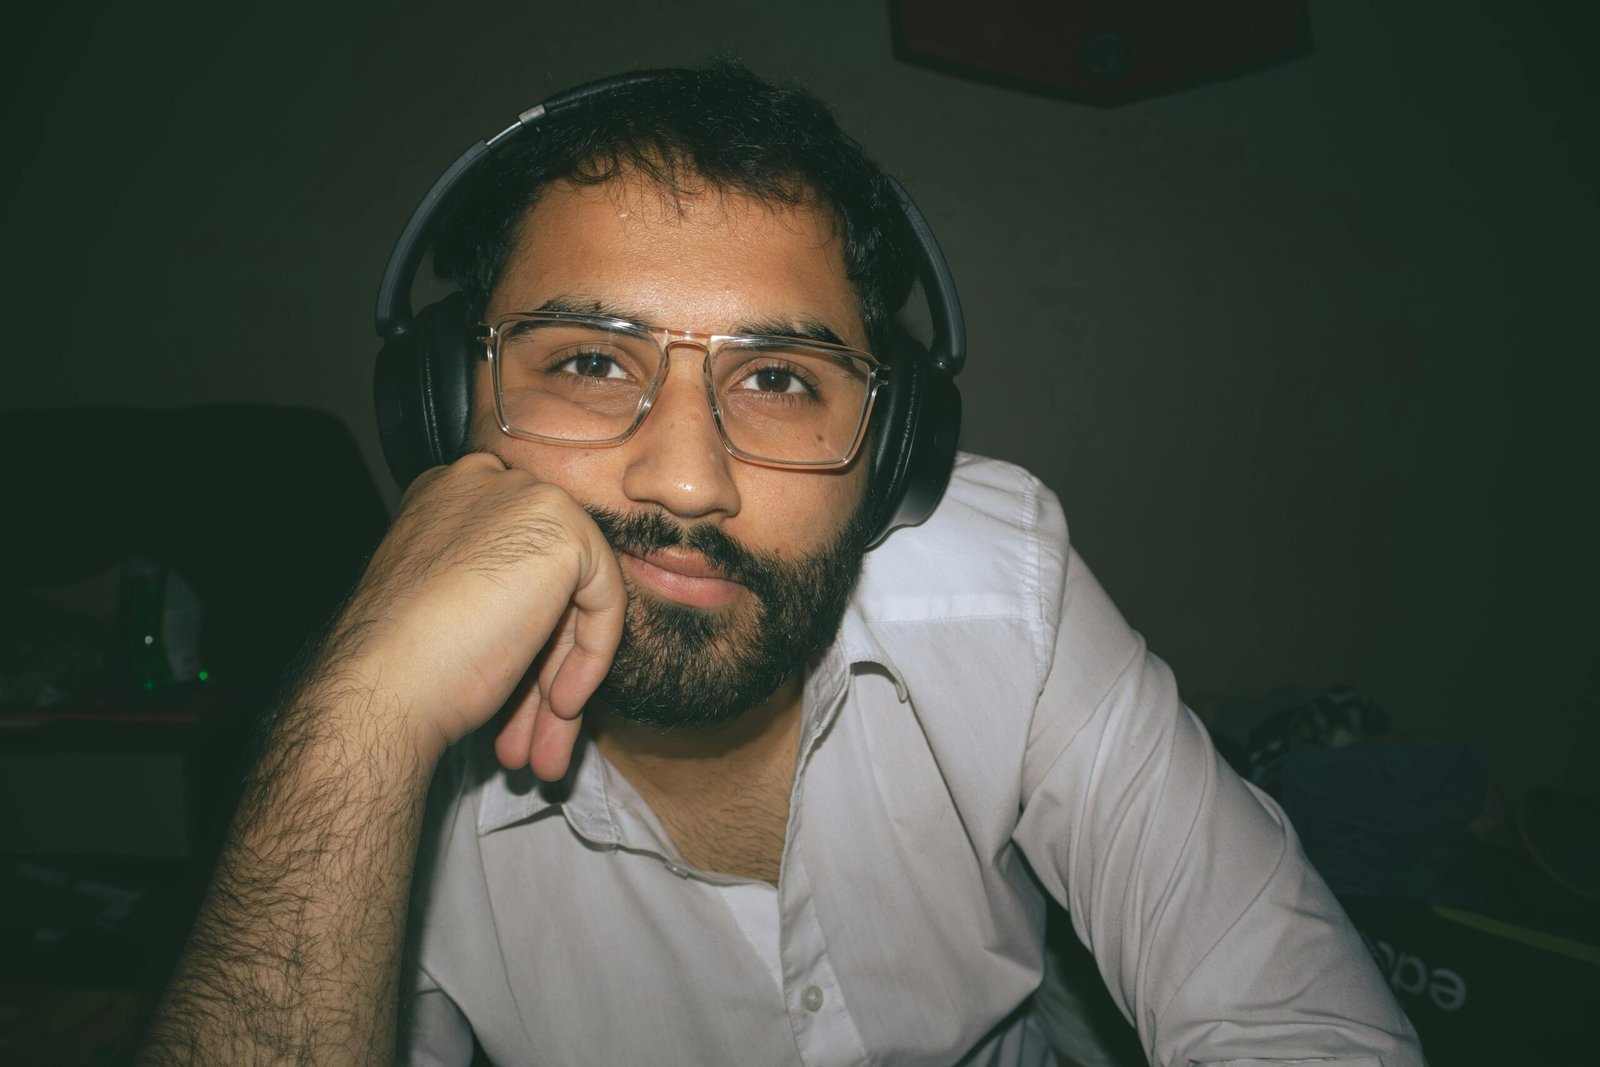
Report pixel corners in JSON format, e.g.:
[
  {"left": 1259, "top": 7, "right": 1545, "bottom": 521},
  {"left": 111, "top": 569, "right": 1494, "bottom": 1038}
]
[{"left": 482, "top": 312, "right": 888, "bottom": 469}]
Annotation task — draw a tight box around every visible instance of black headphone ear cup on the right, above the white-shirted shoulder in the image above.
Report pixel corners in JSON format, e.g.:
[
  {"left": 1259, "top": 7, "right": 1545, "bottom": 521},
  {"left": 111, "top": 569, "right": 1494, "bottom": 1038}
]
[{"left": 869, "top": 323, "right": 962, "bottom": 547}]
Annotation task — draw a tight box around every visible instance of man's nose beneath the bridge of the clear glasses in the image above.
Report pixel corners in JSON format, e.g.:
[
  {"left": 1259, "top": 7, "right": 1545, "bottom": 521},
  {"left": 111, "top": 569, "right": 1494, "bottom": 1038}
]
[{"left": 622, "top": 346, "right": 739, "bottom": 520}]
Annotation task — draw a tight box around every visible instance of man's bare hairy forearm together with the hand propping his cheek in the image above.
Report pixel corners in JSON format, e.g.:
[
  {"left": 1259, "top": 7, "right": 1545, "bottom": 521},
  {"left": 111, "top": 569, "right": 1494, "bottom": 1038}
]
[{"left": 139, "top": 453, "right": 627, "bottom": 1064}]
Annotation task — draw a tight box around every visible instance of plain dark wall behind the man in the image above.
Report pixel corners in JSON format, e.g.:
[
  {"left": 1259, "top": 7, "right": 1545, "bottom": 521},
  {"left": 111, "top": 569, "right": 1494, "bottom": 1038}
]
[{"left": 0, "top": 0, "right": 1600, "bottom": 792}]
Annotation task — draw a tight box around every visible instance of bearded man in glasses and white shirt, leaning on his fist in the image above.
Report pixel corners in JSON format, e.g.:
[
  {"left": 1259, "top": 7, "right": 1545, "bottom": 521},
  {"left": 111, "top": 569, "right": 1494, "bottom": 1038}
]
[{"left": 134, "top": 67, "right": 1421, "bottom": 1064}]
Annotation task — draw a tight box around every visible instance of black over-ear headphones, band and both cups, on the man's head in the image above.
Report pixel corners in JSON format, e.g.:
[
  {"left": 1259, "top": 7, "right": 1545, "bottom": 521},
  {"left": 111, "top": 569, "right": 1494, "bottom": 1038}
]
[{"left": 373, "top": 70, "right": 966, "bottom": 545}]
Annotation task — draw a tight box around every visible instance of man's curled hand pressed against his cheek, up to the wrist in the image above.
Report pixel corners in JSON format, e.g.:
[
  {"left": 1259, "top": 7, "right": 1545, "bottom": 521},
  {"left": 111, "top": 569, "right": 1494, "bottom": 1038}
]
[{"left": 330, "top": 453, "right": 627, "bottom": 781}]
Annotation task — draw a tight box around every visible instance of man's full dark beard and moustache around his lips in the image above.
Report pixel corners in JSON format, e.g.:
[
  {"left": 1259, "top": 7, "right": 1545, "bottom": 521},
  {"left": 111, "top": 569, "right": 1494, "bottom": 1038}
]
[{"left": 586, "top": 491, "right": 872, "bottom": 729}]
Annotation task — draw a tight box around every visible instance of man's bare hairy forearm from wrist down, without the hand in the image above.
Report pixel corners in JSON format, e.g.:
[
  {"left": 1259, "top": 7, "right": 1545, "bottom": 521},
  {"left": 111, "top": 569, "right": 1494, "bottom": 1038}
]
[{"left": 139, "top": 678, "right": 434, "bottom": 1064}]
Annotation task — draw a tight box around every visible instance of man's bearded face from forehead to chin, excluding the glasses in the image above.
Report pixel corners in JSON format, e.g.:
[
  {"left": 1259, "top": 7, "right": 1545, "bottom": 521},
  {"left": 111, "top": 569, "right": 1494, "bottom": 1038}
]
[{"left": 472, "top": 178, "right": 870, "bottom": 726}]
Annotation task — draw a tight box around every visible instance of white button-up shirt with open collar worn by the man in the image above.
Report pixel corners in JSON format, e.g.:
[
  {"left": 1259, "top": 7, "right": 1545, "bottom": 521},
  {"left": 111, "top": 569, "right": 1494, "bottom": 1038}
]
[{"left": 402, "top": 456, "right": 1422, "bottom": 1067}]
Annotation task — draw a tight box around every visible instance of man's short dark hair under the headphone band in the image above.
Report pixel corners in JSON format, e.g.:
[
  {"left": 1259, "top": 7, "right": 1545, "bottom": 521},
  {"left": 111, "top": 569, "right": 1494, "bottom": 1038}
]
[{"left": 434, "top": 61, "right": 915, "bottom": 352}]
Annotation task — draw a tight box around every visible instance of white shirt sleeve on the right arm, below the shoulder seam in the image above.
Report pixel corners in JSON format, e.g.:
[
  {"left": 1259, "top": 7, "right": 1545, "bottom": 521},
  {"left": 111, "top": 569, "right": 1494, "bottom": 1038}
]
[{"left": 1014, "top": 555, "right": 1424, "bottom": 1067}]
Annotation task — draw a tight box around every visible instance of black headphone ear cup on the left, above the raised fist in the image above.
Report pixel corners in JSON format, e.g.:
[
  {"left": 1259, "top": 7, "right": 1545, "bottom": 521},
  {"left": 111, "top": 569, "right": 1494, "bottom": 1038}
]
[{"left": 373, "top": 293, "right": 477, "bottom": 488}]
